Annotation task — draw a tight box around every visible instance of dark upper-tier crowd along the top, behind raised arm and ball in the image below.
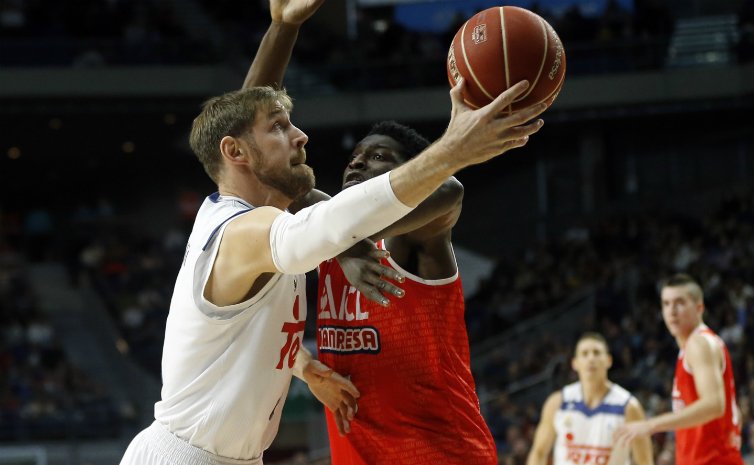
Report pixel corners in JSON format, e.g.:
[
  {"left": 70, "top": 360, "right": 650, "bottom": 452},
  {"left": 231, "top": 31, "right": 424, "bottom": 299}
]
[{"left": 5, "top": 0, "right": 754, "bottom": 80}]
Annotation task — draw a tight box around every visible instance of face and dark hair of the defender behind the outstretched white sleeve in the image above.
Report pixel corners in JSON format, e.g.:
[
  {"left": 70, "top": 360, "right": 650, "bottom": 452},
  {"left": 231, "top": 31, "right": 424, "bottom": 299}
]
[{"left": 343, "top": 134, "right": 407, "bottom": 189}]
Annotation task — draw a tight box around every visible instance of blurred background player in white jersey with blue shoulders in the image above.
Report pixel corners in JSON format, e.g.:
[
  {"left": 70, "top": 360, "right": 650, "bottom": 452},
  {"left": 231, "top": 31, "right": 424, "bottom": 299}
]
[{"left": 526, "top": 333, "right": 654, "bottom": 465}]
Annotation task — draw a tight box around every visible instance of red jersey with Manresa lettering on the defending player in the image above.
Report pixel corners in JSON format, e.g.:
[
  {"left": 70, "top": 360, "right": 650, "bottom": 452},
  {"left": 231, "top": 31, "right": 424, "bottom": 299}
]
[{"left": 317, "top": 245, "right": 497, "bottom": 465}]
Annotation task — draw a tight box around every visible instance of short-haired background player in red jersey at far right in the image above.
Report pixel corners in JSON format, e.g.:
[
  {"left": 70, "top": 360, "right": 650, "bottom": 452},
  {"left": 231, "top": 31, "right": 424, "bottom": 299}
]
[{"left": 616, "top": 274, "right": 743, "bottom": 465}]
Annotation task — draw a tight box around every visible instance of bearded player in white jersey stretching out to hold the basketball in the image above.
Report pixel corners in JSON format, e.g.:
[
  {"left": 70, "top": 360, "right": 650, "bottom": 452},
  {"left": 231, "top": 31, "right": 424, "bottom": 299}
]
[{"left": 121, "top": 0, "right": 546, "bottom": 458}]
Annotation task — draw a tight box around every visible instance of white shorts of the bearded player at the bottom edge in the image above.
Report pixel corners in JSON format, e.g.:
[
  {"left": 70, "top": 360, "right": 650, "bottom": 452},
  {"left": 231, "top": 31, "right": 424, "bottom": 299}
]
[{"left": 120, "top": 421, "right": 262, "bottom": 465}]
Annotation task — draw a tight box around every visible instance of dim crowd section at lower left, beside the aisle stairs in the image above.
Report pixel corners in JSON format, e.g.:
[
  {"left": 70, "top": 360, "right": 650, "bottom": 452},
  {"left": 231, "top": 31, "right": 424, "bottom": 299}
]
[{"left": 0, "top": 232, "right": 120, "bottom": 441}]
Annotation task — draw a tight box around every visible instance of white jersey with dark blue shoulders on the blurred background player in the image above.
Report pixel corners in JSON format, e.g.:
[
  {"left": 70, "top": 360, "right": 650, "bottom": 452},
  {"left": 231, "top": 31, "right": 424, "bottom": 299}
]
[{"left": 553, "top": 382, "right": 631, "bottom": 465}]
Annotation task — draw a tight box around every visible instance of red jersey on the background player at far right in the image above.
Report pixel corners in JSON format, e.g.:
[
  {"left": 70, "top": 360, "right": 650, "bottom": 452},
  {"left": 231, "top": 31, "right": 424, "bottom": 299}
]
[{"left": 673, "top": 325, "right": 743, "bottom": 465}]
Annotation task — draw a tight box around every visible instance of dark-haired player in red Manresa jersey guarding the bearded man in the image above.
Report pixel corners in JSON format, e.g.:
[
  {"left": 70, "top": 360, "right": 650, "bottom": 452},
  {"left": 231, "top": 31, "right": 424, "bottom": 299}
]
[{"left": 247, "top": 0, "right": 498, "bottom": 465}]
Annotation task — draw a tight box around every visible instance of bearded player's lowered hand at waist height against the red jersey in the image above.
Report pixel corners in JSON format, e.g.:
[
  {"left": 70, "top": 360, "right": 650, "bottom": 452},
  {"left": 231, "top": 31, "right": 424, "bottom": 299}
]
[{"left": 293, "top": 346, "right": 361, "bottom": 435}]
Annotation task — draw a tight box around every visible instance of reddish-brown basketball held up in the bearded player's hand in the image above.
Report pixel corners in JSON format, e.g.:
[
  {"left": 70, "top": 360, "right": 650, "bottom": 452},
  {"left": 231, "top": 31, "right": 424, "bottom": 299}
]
[{"left": 447, "top": 6, "right": 566, "bottom": 114}]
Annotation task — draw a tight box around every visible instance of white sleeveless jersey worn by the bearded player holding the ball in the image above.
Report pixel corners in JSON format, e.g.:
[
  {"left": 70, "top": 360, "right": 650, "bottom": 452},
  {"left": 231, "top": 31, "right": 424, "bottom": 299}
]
[{"left": 155, "top": 193, "right": 306, "bottom": 463}]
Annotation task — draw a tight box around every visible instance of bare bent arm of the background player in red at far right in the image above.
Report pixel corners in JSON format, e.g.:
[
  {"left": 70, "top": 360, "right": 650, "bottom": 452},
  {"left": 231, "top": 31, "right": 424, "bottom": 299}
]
[{"left": 616, "top": 333, "right": 725, "bottom": 443}]
